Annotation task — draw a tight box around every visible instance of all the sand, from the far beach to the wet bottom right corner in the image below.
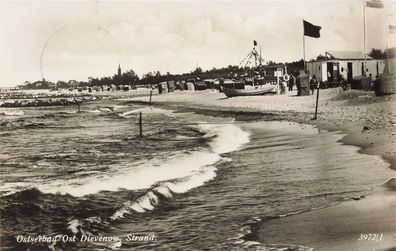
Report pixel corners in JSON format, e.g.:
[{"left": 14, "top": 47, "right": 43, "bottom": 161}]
[{"left": 130, "top": 89, "right": 396, "bottom": 250}]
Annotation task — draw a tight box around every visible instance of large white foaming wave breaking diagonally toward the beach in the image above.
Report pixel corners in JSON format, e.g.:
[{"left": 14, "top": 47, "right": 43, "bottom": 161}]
[{"left": 37, "top": 124, "right": 249, "bottom": 201}]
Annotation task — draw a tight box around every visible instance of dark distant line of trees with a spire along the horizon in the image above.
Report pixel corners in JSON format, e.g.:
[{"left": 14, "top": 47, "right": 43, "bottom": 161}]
[{"left": 5, "top": 48, "right": 390, "bottom": 91}]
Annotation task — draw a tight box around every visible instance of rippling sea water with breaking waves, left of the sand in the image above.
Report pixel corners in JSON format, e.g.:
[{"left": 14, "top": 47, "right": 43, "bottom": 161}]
[{"left": 0, "top": 100, "right": 394, "bottom": 250}]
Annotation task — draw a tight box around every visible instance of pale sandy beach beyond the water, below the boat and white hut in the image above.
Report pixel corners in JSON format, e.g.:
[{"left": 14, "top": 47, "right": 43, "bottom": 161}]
[{"left": 130, "top": 89, "right": 396, "bottom": 169}]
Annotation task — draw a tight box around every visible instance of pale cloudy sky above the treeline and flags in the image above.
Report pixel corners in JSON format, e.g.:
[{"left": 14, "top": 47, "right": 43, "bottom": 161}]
[{"left": 0, "top": 0, "right": 396, "bottom": 87}]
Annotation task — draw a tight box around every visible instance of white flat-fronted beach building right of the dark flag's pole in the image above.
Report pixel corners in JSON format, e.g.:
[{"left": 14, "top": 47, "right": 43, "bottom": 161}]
[{"left": 307, "top": 51, "right": 385, "bottom": 87}]
